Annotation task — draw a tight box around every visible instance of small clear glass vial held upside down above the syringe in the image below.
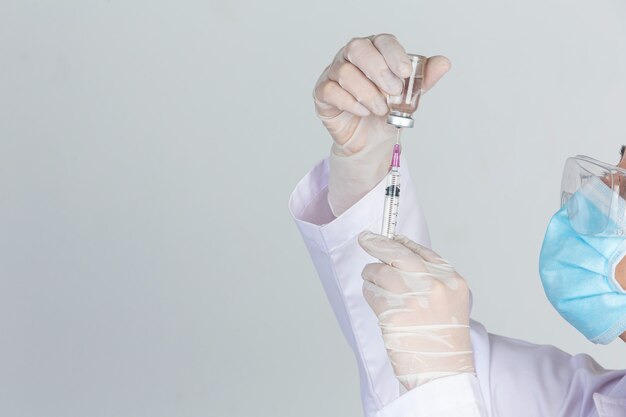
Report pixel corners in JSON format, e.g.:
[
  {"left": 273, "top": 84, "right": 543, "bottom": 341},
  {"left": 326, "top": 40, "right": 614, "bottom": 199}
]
[{"left": 387, "top": 54, "right": 427, "bottom": 128}]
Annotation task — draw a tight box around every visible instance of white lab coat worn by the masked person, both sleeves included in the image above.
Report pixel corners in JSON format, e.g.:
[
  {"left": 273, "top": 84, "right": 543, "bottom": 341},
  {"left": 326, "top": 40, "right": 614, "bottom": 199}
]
[{"left": 289, "top": 160, "right": 626, "bottom": 417}]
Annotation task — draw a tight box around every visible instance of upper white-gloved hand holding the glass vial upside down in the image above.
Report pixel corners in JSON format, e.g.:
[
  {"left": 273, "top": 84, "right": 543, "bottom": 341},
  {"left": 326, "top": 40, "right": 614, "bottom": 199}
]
[{"left": 313, "top": 34, "right": 450, "bottom": 216}]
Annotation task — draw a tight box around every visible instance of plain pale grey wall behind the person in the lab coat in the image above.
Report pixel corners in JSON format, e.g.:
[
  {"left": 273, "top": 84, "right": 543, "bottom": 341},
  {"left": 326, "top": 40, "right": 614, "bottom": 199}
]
[{"left": 0, "top": 0, "right": 626, "bottom": 417}]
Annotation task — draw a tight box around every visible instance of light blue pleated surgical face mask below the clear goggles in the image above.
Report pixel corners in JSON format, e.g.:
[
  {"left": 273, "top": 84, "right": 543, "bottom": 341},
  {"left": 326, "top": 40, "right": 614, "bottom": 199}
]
[{"left": 539, "top": 177, "right": 626, "bottom": 344}]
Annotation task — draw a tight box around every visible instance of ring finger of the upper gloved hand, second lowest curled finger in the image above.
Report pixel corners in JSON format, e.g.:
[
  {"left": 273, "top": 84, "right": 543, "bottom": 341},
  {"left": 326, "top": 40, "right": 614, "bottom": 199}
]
[{"left": 328, "top": 56, "right": 389, "bottom": 116}]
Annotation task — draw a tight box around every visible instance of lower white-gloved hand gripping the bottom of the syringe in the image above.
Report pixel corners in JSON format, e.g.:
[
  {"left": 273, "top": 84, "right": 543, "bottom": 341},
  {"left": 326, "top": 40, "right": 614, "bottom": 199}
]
[{"left": 359, "top": 232, "right": 475, "bottom": 390}]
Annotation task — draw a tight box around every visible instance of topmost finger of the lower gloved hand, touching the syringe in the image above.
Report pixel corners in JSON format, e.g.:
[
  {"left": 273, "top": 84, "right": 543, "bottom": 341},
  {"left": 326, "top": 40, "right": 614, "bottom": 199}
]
[{"left": 358, "top": 231, "right": 426, "bottom": 272}]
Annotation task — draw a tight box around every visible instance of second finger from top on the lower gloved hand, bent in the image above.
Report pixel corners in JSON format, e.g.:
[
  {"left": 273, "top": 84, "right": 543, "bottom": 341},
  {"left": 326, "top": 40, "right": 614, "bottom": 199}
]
[{"left": 361, "top": 262, "right": 432, "bottom": 296}]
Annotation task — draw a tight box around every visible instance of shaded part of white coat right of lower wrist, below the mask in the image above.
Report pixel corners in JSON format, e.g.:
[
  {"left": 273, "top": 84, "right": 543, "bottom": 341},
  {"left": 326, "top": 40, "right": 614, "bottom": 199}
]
[{"left": 472, "top": 322, "right": 626, "bottom": 417}]
